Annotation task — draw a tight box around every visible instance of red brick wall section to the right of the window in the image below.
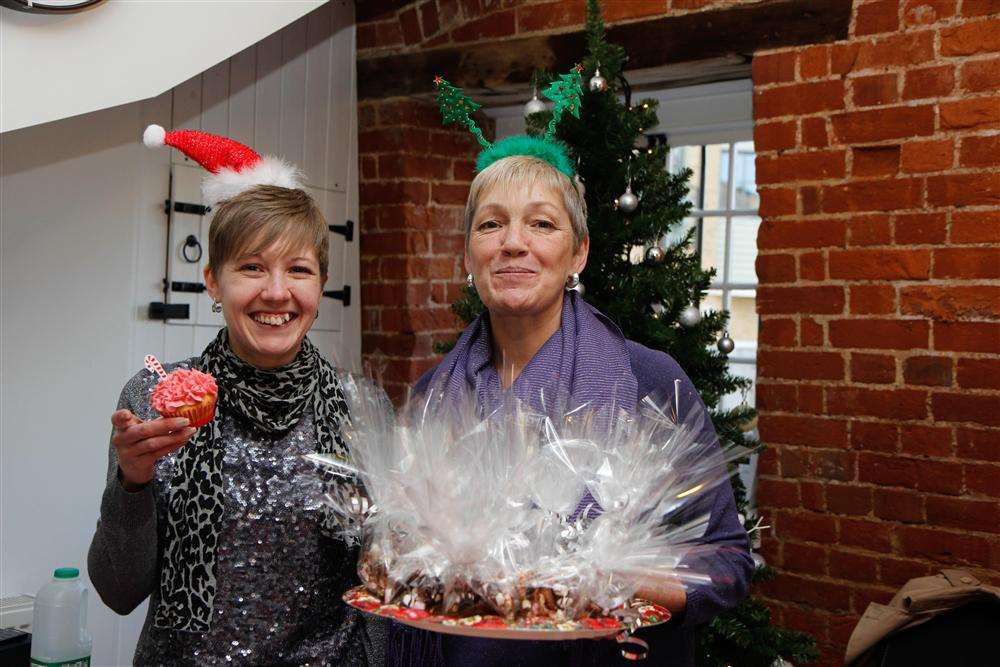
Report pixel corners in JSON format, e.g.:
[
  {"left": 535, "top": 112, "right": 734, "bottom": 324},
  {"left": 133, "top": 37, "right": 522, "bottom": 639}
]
[{"left": 753, "top": 0, "right": 1000, "bottom": 662}]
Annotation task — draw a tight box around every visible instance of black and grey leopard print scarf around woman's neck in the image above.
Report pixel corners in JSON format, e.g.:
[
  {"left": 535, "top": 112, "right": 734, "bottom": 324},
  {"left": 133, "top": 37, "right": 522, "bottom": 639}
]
[{"left": 153, "top": 329, "right": 348, "bottom": 632}]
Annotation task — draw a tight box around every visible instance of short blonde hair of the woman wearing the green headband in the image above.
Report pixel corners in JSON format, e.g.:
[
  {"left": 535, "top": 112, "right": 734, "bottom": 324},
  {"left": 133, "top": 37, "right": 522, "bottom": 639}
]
[{"left": 465, "top": 155, "right": 589, "bottom": 251}]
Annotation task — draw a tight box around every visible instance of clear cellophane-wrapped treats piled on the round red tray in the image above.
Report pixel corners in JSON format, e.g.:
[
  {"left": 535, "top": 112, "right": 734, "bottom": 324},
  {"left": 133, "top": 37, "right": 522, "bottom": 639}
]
[{"left": 308, "top": 378, "right": 747, "bottom": 620}]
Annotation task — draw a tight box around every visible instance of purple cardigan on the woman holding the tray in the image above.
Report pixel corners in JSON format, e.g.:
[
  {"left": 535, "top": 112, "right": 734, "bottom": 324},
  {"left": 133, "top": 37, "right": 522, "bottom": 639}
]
[{"left": 387, "top": 341, "right": 753, "bottom": 667}]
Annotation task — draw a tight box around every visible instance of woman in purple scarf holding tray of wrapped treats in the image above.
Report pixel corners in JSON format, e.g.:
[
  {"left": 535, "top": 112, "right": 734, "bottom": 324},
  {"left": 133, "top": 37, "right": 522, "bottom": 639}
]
[{"left": 389, "top": 155, "right": 752, "bottom": 667}]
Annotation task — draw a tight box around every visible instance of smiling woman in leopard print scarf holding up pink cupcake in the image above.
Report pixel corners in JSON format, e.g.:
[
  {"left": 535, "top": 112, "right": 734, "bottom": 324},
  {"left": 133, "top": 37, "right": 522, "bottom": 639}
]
[{"left": 88, "top": 129, "right": 380, "bottom": 665}]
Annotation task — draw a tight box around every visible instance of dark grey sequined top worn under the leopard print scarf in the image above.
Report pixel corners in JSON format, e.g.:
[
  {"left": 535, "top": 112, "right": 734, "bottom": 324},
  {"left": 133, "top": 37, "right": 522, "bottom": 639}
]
[{"left": 88, "top": 360, "right": 381, "bottom": 665}]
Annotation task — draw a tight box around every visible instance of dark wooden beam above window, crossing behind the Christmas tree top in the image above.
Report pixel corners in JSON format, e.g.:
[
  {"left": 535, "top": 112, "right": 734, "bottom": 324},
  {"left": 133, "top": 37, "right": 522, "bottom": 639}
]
[{"left": 358, "top": 0, "right": 852, "bottom": 99}]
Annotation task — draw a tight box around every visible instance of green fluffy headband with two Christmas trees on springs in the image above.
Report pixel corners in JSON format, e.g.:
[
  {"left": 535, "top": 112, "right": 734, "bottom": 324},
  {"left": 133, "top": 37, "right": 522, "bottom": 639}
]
[{"left": 434, "top": 65, "right": 583, "bottom": 179}]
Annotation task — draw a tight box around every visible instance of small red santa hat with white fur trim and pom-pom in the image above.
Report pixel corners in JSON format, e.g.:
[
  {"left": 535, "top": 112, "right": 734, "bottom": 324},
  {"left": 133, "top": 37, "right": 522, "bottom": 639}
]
[{"left": 142, "top": 125, "right": 303, "bottom": 206}]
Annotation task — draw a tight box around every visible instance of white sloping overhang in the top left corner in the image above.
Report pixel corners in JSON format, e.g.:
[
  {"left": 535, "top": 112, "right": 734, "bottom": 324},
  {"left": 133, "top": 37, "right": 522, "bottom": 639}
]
[{"left": 0, "top": 0, "right": 324, "bottom": 132}]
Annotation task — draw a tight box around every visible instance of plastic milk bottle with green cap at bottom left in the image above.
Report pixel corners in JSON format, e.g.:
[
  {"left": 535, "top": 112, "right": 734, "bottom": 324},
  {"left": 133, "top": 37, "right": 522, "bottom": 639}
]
[{"left": 31, "top": 567, "right": 91, "bottom": 667}]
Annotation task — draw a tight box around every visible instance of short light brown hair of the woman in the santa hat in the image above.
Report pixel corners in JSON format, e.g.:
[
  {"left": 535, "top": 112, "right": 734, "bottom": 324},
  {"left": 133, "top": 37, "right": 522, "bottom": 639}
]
[{"left": 208, "top": 185, "right": 330, "bottom": 278}]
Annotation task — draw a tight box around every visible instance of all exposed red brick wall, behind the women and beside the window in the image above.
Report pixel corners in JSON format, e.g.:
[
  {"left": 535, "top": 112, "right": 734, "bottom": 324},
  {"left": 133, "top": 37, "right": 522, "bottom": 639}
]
[{"left": 358, "top": 0, "right": 1000, "bottom": 664}]
